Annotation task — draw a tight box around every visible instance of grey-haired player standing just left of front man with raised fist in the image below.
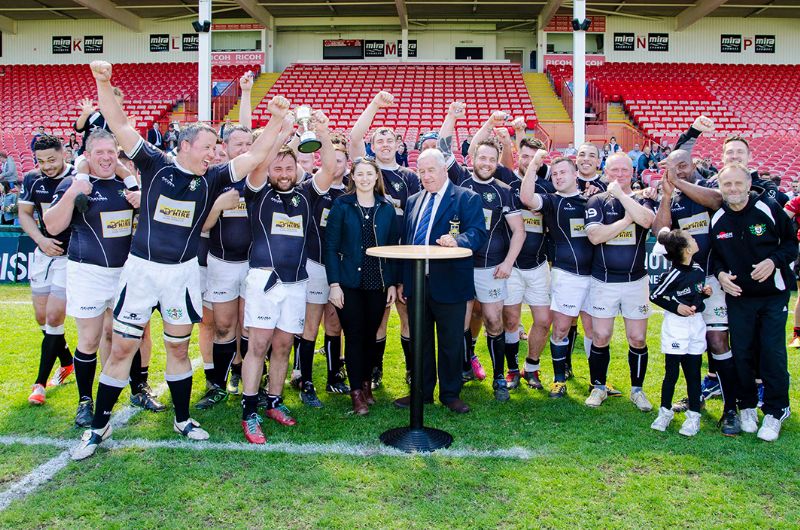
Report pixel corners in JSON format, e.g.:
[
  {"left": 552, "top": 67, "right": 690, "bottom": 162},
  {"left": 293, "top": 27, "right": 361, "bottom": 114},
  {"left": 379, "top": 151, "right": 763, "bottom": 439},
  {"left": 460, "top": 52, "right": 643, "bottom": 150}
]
[{"left": 44, "top": 129, "right": 166, "bottom": 427}]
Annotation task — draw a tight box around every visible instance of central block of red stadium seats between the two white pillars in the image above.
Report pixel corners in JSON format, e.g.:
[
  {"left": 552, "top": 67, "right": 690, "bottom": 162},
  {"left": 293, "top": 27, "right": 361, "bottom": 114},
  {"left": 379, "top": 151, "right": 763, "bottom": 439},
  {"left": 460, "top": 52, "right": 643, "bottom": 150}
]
[{"left": 253, "top": 63, "right": 537, "bottom": 148}]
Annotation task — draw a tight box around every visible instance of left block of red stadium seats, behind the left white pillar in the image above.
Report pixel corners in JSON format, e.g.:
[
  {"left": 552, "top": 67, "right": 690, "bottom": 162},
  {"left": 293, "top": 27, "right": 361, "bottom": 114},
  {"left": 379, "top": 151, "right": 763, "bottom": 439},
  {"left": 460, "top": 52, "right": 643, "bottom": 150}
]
[{"left": 0, "top": 62, "right": 259, "bottom": 172}]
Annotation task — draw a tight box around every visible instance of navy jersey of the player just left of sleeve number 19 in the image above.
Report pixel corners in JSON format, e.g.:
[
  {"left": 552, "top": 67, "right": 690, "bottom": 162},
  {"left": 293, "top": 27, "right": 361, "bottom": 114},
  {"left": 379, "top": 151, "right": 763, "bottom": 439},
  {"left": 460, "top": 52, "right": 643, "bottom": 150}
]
[{"left": 539, "top": 193, "right": 594, "bottom": 276}]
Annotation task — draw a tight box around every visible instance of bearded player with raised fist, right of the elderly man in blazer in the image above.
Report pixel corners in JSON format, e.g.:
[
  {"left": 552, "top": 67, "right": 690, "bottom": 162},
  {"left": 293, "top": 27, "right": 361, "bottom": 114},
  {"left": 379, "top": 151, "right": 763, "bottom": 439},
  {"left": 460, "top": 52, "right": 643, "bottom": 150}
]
[{"left": 439, "top": 102, "right": 525, "bottom": 401}]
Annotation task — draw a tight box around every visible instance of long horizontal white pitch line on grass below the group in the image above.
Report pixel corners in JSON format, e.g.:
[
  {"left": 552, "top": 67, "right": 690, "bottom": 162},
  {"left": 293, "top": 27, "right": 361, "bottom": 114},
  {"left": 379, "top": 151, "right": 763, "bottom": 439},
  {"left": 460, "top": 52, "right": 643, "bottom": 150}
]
[{"left": 0, "top": 436, "right": 544, "bottom": 460}]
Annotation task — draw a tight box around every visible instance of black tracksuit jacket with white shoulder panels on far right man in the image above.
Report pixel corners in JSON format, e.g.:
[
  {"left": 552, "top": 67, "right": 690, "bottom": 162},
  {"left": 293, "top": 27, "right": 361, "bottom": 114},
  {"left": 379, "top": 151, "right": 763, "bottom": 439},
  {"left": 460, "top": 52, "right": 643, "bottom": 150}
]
[{"left": 710, "top": 192, "right": 797, "bottom": 296}]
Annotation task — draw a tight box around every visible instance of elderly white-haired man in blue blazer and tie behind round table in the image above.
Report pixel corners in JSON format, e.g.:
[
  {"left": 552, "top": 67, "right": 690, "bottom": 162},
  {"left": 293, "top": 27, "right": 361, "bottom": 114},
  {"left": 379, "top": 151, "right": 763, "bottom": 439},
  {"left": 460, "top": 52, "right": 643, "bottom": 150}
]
[{"left": 395, "top": 149, "right": 488, "bottom": 414}]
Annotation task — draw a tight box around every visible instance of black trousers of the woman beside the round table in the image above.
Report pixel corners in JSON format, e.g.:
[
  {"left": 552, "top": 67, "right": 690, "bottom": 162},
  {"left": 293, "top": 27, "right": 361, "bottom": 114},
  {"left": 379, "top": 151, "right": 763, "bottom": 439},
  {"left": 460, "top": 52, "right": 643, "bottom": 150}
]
[{"left": 336, "top": 287, "right": 386, "bottom": 390}]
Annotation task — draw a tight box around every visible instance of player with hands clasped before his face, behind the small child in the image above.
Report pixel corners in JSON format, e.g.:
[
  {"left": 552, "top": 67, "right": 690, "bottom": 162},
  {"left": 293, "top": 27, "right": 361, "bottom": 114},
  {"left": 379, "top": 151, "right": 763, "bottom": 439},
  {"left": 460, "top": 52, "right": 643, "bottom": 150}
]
[{"left": 652, "top": 149, "right": 740, "bottom": 435}]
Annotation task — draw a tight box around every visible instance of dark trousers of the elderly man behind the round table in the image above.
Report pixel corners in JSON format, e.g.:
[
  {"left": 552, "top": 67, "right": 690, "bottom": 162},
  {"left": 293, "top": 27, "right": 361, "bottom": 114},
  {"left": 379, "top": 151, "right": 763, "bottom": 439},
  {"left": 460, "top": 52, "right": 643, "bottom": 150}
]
[{"left": 408, "top": 278, "right": 467, "bottom": 403}]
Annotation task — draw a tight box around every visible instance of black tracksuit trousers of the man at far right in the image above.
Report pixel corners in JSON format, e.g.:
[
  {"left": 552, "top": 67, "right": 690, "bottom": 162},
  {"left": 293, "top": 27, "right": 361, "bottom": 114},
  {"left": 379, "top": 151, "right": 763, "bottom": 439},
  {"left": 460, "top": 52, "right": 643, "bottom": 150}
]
[{"left": 725, "top": 291, "right": 789, "bottom": 419}]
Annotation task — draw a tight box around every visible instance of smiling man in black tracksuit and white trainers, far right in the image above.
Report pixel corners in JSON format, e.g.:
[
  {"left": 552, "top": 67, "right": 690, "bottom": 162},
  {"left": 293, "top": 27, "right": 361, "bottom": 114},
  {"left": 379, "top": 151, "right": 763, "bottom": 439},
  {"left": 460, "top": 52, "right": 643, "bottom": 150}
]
[{"left": 710, "top": 164, "right": 797, "bottom": 441}]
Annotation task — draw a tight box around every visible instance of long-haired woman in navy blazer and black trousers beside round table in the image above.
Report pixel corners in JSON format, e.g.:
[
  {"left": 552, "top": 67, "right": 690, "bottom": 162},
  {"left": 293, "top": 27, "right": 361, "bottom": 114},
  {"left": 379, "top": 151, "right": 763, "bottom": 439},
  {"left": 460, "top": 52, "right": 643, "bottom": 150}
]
[{"left": 325, "top": 159, "right": 400, "bottom": 416}]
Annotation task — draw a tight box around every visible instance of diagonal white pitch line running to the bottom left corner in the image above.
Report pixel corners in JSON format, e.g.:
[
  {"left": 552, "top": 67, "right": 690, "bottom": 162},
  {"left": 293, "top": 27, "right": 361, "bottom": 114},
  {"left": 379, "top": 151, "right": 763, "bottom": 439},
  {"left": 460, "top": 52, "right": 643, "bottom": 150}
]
[{"left": 0, "top": 359, "right": 202, "bottom": 512}]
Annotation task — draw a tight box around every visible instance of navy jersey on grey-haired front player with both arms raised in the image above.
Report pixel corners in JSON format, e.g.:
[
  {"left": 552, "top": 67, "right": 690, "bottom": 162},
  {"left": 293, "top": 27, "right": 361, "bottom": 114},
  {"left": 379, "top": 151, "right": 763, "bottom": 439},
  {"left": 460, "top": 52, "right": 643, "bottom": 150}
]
[{"left": 128, "top": 139, "right": 235, "bottom": 264}]
